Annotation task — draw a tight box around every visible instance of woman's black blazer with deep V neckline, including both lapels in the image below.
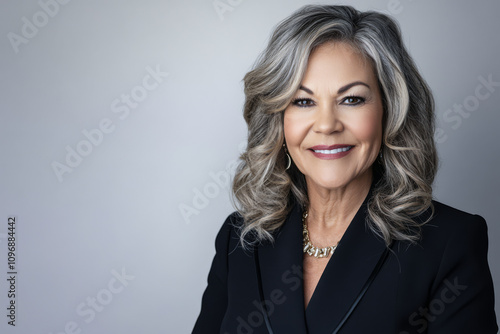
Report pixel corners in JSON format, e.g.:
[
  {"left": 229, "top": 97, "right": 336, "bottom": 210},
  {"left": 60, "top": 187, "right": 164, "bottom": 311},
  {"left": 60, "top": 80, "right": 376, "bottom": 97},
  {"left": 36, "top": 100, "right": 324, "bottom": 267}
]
[{"left": 193, "top": 189, "right": 498, "bottom": 334}]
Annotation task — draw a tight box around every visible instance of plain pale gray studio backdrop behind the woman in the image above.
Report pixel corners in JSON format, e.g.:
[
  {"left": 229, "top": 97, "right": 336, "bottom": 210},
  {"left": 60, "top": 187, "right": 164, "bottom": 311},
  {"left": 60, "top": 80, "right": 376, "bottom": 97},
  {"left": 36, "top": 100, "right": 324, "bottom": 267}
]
[{"left": 0, "top": 0, "right": 500, "bottom": 334}]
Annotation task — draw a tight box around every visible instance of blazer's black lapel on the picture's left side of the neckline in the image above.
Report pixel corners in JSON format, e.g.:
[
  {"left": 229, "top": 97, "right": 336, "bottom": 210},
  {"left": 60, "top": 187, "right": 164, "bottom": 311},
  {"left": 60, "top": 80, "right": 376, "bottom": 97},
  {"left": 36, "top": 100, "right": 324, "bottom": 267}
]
[{"left": 258, "top": 205, "right": 307, "bottom": 333}]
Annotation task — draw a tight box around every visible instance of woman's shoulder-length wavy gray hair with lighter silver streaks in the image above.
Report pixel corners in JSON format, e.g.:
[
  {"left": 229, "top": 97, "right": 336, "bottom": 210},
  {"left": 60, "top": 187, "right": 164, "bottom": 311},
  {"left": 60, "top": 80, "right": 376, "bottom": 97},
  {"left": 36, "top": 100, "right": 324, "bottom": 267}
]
[{"left": 233, "top": 5, "right": 437, "bottom": 245}]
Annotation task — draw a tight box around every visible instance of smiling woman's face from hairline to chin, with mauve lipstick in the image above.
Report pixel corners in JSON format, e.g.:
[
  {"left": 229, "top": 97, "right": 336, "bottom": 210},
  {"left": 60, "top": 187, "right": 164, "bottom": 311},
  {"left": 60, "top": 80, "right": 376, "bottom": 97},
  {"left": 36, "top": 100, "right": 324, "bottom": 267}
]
[{"left": 284, "top": 42, "right": 383, "bottom": 190}]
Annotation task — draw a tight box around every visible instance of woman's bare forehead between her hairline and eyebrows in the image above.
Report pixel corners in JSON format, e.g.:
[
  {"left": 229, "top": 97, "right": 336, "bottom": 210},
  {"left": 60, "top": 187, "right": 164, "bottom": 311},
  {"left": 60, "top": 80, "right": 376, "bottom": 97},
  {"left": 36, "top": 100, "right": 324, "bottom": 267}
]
[{"left": 302, "top": 42, "right": 376, "bottom": 86}]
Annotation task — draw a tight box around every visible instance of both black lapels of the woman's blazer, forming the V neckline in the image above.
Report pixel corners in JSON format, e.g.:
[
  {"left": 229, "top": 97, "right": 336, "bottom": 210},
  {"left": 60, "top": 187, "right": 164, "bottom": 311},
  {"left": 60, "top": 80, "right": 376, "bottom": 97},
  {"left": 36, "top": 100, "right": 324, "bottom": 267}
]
[{"left": 258, "top": 189, "right": 385, "bottom": 334}]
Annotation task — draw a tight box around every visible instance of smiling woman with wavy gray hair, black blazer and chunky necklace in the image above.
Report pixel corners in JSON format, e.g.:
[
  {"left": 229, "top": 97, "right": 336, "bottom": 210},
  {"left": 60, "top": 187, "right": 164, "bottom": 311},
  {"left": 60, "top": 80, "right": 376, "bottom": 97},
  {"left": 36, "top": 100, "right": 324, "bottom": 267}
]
[{"left": 193, "top": 6, "right": 498, "bottom": 334}]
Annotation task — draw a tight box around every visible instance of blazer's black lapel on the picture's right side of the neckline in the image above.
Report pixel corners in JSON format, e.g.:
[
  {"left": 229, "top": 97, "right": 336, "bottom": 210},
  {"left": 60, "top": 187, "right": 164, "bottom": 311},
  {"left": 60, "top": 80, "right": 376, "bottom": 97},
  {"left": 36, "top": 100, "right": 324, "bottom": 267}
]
[{"left": 305, "top": 191, "right": 386, "bottom": 334}]
